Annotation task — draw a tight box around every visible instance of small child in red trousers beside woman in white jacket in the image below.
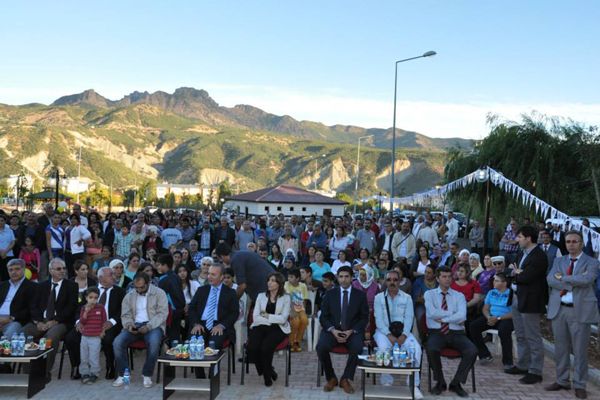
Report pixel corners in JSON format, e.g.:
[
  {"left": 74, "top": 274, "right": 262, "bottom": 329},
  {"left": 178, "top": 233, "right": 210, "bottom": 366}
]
[{"left": 284, "top": 268, "right": 308, "bottom": 352}]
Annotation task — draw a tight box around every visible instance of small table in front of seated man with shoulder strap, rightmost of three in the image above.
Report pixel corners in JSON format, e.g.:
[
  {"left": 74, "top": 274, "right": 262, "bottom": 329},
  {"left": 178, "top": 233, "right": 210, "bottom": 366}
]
[{"left": 358, "top": 359, "right": 421, "bottom": 400}]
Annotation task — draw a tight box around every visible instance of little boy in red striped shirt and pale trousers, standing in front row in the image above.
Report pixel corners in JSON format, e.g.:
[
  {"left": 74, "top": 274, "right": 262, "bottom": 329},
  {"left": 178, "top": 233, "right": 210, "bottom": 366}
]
[{"left": 79, "top": 287, "right": 107, "bottom": 385}]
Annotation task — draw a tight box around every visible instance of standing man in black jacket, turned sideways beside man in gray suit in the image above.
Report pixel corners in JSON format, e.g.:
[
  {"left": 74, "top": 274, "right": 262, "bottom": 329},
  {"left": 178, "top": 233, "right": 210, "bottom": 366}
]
[{"left": 504, "top": 225, "right": 548, "bottom": 385}]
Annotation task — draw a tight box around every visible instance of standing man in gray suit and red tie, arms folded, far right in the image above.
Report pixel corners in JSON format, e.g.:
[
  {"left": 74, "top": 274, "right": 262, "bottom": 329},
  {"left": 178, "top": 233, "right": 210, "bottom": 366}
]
[{"left": 546, "top": 231, "right": 600, "bottom": 399}]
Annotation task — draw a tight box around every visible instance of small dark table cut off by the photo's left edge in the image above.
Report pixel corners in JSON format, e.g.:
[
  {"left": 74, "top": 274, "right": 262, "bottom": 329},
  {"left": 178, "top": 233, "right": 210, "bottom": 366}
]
[{"left": 0, "top": 348, "right": 53, "bottom": 399}]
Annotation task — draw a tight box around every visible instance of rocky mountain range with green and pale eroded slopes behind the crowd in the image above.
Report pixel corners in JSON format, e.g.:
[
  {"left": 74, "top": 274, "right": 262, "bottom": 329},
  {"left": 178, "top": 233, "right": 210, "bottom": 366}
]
[{"left": 0, "top": 88, "right": 460, "bottom": 195}]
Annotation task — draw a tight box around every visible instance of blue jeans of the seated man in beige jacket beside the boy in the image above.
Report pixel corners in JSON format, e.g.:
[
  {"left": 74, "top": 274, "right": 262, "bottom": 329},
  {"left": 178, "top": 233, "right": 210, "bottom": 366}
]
[{"left": 113, "top": 328, "right": 163, "bottom": 377}]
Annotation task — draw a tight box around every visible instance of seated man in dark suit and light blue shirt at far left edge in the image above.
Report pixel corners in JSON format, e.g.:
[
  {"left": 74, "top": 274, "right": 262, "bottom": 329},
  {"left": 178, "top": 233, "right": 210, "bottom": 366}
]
[{"left": 0, "top": 258, "right": 37, "bottom": 339}]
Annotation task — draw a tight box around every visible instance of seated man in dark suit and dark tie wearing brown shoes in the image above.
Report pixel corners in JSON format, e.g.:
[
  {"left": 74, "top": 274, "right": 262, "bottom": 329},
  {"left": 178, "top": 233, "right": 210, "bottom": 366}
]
[{"left": 317, "top": 266, "right": 369, "bottom": 394}]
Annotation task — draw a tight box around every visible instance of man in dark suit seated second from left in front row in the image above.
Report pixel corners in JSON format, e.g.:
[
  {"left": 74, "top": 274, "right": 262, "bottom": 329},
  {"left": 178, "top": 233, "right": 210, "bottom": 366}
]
[{"left": 24, "top": 258, "right": 79, "bottom": 379}]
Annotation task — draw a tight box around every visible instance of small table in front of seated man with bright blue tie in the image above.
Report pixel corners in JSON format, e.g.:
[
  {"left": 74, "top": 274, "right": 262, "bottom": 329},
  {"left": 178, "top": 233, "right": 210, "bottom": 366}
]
[{"left": 158, "top": 350, "right": 227, "bottom": 400}]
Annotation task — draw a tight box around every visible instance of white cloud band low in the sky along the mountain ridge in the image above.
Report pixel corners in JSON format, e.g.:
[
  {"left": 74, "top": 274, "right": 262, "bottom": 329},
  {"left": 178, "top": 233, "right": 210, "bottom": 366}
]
[{"left": 0, "top": 83, "right": 600, "bottom": 139}]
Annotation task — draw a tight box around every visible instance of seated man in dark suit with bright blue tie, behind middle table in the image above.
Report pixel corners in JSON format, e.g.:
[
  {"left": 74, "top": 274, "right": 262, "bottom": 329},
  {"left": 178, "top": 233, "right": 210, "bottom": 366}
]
[{"left": 188, "top": 264, "right": 240, "bottom": 377}]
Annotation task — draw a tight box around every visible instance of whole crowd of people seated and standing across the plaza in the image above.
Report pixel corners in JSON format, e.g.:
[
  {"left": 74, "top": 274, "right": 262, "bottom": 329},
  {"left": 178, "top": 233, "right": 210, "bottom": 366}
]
[{"left": 0, "top": 204, "right": 600, "bottom": 398}]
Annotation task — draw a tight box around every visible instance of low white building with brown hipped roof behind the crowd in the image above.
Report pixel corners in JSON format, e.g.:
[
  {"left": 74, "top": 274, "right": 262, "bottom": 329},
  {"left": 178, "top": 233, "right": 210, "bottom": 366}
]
[{"left": 225, "top": 185, "right": 347, "bottom": 216}]
